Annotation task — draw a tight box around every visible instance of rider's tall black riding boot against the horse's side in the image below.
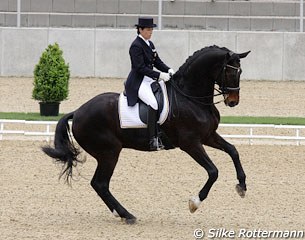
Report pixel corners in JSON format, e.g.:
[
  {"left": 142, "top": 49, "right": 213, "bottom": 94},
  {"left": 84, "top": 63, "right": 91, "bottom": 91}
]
[{"left": 147, "top": 106, "right": 164, "bottom": 151}]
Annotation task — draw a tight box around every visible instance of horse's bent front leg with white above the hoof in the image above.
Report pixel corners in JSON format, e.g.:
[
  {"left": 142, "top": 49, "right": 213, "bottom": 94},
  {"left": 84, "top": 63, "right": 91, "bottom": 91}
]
[{"left": 180, "top": 143, "right": 218, "bottom": 213}]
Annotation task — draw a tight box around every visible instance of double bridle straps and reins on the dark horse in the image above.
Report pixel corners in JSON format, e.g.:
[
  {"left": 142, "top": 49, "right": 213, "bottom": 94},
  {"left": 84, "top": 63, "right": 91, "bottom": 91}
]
[{"left": 169, "top": 61, "right": 242, "bottom": 105}]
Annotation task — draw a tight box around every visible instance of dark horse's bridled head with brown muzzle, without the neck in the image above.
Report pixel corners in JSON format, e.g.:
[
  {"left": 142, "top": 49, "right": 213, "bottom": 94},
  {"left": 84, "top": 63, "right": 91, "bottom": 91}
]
[{"left": 216, "top": 51, "right": 250, "bottom": 107}]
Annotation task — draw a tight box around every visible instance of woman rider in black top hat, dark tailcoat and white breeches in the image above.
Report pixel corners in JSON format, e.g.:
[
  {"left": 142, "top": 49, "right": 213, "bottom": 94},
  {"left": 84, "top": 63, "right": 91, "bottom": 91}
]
[{"left": 125, "top": 17, "right": 175, "bottom": 151}]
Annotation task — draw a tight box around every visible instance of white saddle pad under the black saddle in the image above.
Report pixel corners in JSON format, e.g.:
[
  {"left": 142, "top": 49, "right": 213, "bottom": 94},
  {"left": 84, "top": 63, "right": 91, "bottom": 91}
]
[{"left": 119, "top": 81, "right": 169, "bottom": 128}]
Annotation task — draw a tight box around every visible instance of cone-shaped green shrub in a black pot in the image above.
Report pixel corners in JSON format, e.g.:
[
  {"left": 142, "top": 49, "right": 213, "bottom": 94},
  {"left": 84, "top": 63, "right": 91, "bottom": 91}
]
[{"left": 32, "top": 43, "right": 70, "bottom": 116}]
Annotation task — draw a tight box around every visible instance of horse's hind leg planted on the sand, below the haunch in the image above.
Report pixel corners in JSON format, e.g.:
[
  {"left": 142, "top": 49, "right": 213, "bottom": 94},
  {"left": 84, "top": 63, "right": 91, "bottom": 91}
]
[{"left": 91, "top": 152, "right": 136, "bottom": 224}]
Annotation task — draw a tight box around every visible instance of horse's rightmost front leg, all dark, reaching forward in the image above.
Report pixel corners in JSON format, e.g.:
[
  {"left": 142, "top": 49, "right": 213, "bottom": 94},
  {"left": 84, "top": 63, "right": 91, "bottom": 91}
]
[{"left": 205, "top": 132, "right": 247, "bottom": 197}]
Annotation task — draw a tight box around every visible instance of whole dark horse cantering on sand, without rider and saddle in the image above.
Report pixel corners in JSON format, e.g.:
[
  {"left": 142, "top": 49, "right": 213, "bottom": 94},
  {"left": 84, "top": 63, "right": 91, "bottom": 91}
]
[{"left": 43, "top": 46, "right": 250, "bottom": 224}]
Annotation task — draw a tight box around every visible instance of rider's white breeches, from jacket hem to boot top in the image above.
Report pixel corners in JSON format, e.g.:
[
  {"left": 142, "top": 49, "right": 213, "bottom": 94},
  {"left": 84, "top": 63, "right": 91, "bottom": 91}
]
[{"left": 138, "top": 76, "right": 158, "bottom": 110}]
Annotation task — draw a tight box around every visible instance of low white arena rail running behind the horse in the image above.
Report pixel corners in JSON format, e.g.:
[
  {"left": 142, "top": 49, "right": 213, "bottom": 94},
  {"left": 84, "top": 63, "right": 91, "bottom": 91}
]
[{"left": 0, "top": 119, "right": 305, "bottom": 146}]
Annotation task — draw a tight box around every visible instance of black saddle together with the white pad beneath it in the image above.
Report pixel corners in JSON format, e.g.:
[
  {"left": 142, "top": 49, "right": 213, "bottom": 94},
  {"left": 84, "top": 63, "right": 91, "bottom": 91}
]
[{"left": 119, "top": 82, "right": 169, "bottom": 128}]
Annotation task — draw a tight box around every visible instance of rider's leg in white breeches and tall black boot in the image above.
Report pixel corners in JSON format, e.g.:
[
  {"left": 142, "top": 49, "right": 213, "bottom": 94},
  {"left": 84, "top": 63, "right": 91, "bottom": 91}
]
[{"left": 138, "top": 77, "right": 164, "bottom": 151}]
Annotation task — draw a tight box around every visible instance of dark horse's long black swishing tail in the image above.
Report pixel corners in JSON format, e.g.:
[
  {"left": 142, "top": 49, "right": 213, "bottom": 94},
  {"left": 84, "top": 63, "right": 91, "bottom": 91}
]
[{"left": 42, "top": 112, "right": 83, "bottom": 183}]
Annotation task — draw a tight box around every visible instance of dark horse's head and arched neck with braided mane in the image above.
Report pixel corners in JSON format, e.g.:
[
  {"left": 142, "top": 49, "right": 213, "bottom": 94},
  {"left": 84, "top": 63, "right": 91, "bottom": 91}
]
[{"left": 171, "top": 45, "right": 250, "bottom": 107}]
